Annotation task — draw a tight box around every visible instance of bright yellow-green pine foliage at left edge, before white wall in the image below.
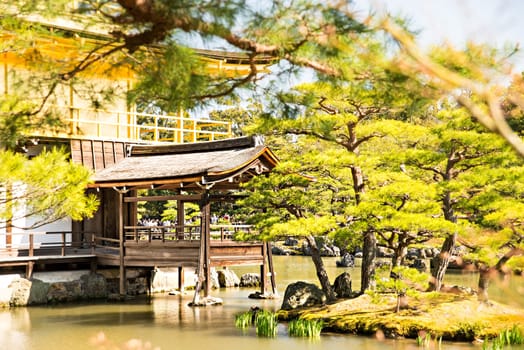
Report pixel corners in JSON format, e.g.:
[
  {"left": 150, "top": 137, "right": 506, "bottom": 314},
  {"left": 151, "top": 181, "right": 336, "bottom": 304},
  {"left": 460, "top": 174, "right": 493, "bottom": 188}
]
[{"left": 0, "top": 149, "right": 98, "bottom": 228}]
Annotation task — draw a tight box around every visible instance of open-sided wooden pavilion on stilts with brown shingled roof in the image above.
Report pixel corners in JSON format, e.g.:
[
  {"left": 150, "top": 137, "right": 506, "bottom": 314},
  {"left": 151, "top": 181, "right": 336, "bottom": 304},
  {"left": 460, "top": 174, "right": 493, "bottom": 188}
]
[{"left": 77, "top": 137, "right": 278, "bottom": 304}]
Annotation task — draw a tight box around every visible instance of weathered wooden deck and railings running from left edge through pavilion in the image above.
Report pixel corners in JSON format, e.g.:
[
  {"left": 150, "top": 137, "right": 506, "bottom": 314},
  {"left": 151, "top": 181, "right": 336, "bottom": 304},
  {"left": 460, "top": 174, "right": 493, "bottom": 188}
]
[{"left": 0, "top": 225, "right": 268, "bottom": 288}]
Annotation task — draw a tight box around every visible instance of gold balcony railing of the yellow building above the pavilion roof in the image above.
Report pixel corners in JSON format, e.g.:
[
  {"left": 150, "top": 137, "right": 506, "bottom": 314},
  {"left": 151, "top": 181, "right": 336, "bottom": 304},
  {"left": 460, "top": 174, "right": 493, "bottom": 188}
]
[{"left": 30, "top": 106, "right": 232, "bottom": 143}]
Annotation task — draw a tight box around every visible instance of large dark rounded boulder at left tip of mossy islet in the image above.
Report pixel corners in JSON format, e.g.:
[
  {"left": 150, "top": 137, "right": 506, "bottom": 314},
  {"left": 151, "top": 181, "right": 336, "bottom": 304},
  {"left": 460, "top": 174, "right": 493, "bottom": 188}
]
[{"left": 281, "top": 281, "right": 326, "bottom": 310}]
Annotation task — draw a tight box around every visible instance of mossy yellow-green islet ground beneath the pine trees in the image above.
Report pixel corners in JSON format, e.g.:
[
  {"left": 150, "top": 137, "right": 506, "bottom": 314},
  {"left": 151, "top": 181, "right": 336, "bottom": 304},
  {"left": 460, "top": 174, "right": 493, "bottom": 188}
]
[{"left": 278, "top": 293, "right": 524, "bottom": 341}]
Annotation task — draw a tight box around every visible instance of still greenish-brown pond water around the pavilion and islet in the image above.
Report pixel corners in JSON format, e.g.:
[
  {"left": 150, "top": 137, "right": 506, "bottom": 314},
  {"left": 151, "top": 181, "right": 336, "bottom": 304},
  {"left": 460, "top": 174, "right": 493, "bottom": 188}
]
[{"left": 0, "top": 257, "right": 524, "bottom": 350}]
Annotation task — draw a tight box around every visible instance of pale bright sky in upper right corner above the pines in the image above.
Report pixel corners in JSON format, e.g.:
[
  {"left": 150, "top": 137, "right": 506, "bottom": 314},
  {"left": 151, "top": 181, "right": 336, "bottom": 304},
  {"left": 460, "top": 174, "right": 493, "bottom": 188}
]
[{"left": 355, "top": 0, "right": 524, "bottom": 68}]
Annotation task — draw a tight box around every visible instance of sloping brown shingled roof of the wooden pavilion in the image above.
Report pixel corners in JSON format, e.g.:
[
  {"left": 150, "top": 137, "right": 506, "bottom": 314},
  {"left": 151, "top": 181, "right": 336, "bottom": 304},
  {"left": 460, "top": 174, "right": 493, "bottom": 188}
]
[{"left": 93, "top": 138, "right": 277, "bottom": 187}]
